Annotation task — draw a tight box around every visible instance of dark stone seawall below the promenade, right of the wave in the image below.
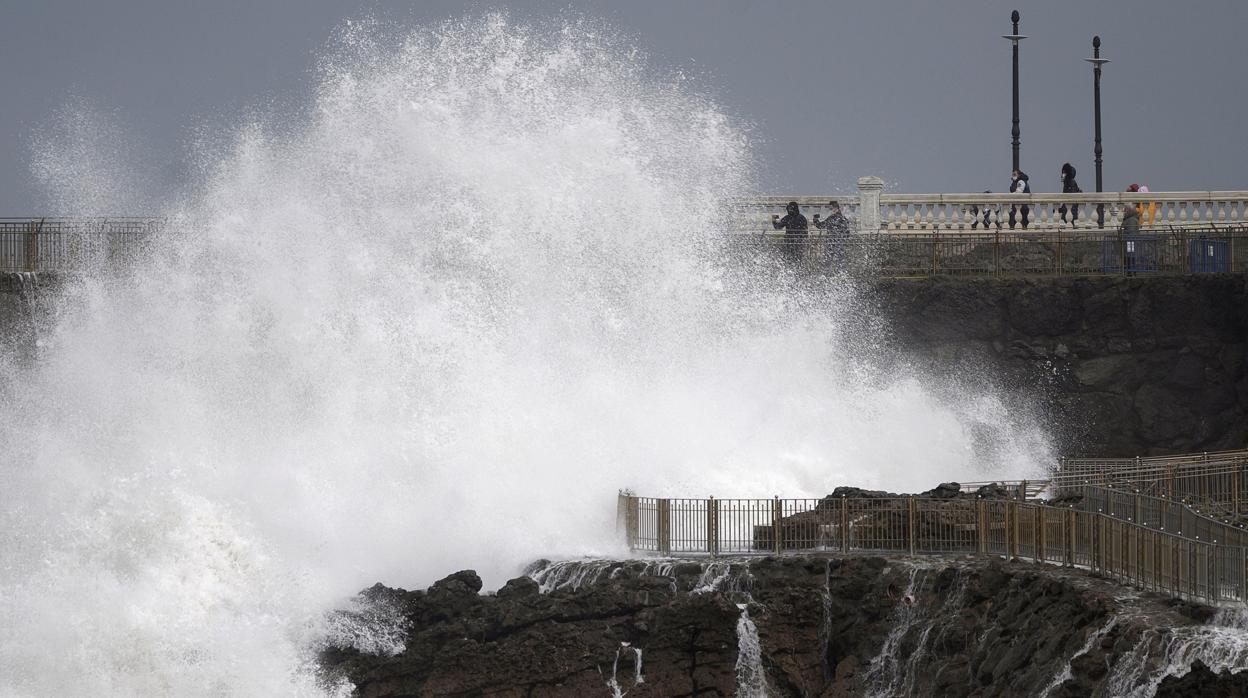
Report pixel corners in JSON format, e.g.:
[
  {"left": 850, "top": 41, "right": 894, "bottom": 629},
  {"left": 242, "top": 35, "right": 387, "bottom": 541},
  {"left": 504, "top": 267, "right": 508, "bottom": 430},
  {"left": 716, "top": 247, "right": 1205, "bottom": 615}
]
[{"left": 865, "top": 275, "right": 1248, "bottom": 457}]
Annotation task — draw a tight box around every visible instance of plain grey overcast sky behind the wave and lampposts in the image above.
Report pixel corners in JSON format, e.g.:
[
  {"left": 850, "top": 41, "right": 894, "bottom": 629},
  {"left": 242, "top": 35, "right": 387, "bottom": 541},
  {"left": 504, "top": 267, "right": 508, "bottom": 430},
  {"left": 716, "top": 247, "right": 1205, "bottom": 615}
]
[{"left": 0, "top": 0, "right": 1248, "bottom": 216}]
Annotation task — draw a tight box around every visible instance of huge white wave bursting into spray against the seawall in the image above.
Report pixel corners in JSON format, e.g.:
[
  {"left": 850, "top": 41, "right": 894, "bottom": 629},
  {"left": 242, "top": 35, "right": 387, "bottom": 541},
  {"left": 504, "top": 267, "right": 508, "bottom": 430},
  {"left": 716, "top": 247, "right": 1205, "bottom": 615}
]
[{"left": 0, "top": 15, "right": 1051, "bottom": 696}]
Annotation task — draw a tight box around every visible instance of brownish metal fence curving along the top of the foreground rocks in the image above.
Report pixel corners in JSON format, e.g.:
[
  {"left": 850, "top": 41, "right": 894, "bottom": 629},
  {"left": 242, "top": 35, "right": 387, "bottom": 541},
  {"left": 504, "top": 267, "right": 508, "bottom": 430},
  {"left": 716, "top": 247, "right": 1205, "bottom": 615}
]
[{"left": 618, "top": 492, "right": 1248, "bottom": 603}]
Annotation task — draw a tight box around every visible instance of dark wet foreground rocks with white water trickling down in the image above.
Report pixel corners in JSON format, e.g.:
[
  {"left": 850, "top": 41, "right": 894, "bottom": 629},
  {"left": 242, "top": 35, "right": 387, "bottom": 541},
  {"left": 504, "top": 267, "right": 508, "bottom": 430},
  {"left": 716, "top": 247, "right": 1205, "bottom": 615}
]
[{"left": 322, "top": 556, "right": 1242, "bottom": 697}]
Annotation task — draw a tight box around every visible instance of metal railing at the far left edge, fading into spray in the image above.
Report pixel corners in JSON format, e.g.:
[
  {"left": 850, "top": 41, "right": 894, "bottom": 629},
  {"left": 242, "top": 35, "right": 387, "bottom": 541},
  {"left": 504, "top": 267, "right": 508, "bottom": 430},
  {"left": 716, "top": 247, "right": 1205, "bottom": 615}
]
[{"left": 0, "top": 217, "right": 165, "bottom": 272}]
